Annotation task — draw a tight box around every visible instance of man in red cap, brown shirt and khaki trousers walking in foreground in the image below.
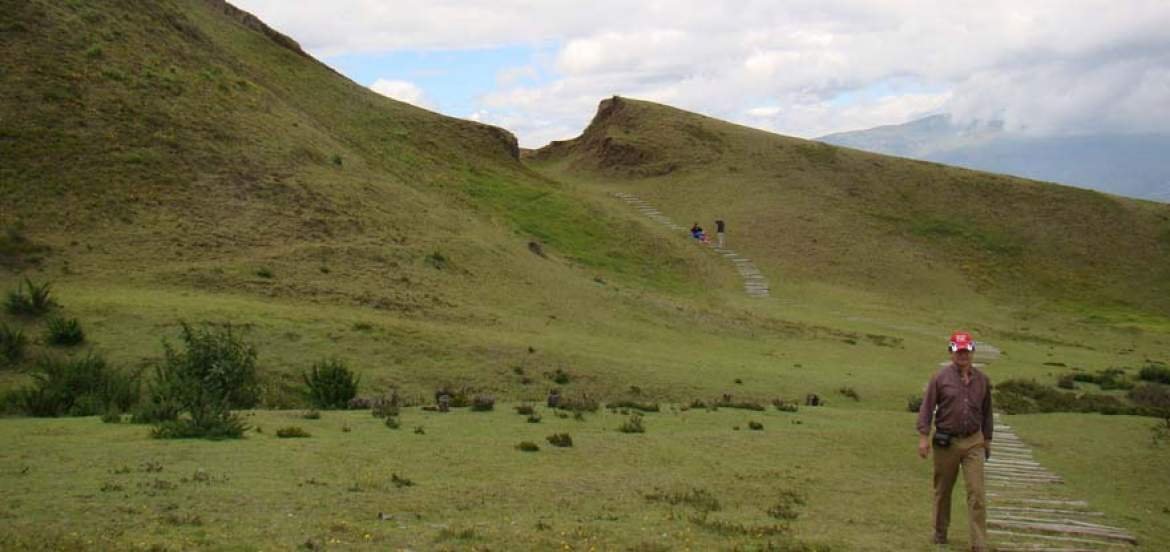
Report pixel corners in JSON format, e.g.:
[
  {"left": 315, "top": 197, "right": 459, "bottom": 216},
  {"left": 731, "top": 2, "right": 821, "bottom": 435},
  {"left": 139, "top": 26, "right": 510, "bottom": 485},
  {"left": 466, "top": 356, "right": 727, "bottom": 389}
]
[{"left": 918, "top": 332, "right": 995, "bottom": 552}]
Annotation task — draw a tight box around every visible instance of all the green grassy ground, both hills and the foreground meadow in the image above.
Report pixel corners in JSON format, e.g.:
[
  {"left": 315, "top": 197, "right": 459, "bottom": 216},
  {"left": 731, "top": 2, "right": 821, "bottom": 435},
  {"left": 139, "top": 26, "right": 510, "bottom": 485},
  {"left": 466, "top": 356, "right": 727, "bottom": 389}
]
[{"left": 0, "top": 0, "right": 1170, "bottom": 552}]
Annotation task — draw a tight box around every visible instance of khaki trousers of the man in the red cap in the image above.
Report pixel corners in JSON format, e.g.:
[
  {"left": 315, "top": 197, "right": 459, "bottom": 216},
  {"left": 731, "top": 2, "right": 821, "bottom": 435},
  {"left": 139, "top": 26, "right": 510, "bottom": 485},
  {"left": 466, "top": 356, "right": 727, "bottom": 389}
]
[{"left": 932, "top": 433, "right": 987, "bottom": 552}]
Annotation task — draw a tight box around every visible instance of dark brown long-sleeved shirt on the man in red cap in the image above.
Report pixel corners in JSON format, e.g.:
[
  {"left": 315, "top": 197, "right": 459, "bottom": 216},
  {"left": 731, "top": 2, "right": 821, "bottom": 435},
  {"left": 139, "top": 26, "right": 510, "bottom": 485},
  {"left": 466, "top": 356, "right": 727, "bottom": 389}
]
[{"left": 918, "top": 363, "right": 995, "bottom": 441}]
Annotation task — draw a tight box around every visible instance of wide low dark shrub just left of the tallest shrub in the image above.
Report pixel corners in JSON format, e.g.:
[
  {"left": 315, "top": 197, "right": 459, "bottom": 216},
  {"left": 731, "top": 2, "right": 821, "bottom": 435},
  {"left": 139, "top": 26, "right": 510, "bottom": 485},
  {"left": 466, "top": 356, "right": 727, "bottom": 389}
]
[{"left": 16, "top": 354, "right": 140, "bottom": 416}]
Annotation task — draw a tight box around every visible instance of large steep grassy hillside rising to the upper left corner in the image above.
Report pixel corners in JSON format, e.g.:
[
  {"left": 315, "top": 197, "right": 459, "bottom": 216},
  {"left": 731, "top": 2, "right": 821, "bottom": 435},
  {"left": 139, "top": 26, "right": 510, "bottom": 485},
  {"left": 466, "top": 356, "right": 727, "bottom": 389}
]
[{"left": 0, "top": 0, "right": 735, "bottom": 394}]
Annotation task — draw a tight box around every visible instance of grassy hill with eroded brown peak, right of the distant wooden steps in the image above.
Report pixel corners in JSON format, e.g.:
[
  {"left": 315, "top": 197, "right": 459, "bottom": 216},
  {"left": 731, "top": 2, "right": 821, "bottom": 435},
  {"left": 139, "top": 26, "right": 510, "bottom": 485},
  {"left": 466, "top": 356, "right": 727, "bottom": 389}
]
[{"left": 529, "top": 97, "right": 1170, "bottom": 315}]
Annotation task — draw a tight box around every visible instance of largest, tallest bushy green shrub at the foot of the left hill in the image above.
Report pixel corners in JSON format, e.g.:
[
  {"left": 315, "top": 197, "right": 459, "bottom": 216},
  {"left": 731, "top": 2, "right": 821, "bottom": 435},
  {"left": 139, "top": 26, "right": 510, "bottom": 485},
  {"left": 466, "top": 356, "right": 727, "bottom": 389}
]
[{"left": 151, "top": 323, "right": 260, "bottom": 439}]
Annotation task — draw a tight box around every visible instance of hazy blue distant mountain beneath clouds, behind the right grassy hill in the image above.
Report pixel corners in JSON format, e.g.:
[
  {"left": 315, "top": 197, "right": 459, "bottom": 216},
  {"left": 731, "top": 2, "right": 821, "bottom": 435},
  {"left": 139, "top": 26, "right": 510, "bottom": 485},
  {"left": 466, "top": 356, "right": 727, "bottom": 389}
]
[{"left": 818, "top": 115, "right": 1170, "bottom": 201}]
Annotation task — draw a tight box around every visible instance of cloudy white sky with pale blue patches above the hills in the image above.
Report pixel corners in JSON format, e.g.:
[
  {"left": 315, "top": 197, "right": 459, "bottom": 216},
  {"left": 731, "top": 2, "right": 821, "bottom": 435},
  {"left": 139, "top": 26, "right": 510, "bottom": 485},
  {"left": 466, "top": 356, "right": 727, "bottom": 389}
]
[{"left": 234, "top": 0, "right": 1170, "bottom": 147}]
